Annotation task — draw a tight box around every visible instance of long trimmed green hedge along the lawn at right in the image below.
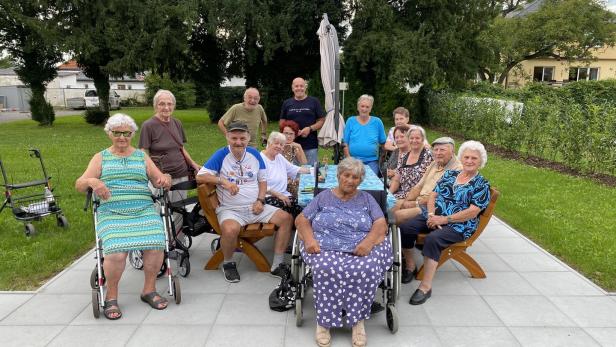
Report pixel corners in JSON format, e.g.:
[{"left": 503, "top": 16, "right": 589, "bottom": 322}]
[{"left": 427, "top": 80, "right": 616, "bottom": 175}]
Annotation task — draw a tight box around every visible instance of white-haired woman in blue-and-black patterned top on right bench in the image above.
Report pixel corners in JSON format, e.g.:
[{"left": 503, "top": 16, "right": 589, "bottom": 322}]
[{"left": 400, "top": 141, "right": 490, "bottom": 305}]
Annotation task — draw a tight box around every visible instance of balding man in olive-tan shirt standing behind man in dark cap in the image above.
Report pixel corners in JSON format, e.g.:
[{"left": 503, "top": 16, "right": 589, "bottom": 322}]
[{"left": 218, "top": 88, "right": 267, "bottom": 147}]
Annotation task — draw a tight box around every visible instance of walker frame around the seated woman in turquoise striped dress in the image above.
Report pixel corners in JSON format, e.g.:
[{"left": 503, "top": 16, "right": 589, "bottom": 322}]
[{"left": 84, "top": 188, "right": 182, "bottom": 318}]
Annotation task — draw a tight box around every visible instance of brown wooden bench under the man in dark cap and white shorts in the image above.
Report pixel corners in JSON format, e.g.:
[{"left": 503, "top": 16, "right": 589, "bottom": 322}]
[{"left": 197, "top": 184, "right": 276, "bottom": 272}]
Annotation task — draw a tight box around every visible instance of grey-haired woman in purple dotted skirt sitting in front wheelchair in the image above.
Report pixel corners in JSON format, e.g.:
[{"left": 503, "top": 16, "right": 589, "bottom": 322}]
[{"left": 296, "top": 158, "right": 393, "bottom": 346}]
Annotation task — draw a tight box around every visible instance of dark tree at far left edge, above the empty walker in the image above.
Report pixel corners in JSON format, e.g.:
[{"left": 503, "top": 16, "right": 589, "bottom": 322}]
[{"left": 0, "top": 0, "right": 62, "bottom": 125}]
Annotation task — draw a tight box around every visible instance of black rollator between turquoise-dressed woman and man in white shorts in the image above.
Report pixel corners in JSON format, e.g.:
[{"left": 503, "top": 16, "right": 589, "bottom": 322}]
[{"left": 128, "top": 180, "right": 214, "bottom": 277}]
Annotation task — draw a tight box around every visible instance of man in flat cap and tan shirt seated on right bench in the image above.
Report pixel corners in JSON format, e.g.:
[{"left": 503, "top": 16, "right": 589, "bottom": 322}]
[{"left": 392, "top": 137, "right": 462, "bottom": 283}]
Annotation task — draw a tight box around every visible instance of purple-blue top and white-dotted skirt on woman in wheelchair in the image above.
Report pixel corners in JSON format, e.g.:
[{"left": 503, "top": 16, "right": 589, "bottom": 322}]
[{"left": 300, "top": 189, "right": 393, "bottom": 328}]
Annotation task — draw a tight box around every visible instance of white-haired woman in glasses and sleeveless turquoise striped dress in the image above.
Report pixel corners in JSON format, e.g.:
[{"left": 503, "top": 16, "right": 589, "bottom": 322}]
[{"left": 75, "top": 113, "right": 171, "bottom": 320}]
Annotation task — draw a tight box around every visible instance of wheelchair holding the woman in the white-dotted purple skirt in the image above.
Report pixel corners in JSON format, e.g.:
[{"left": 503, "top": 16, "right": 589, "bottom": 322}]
[{"left": 291, "top": 187, "right": 402, "bottom": 334}]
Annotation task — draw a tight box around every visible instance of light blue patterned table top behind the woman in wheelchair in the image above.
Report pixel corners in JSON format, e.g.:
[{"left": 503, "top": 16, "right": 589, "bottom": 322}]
[{"left": 297, "top": 165, "right": 396, "bottom": 209}]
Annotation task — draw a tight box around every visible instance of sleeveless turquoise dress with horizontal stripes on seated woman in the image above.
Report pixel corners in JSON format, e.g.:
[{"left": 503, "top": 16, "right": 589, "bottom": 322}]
[{"left": 97, "top": 149, "right": 165, "bottom": 254}]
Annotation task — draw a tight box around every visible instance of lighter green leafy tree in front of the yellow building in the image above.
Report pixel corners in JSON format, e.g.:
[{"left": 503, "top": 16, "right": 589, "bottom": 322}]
[{"left": 481, "top": 0, "right": 616, "bottom": 84}]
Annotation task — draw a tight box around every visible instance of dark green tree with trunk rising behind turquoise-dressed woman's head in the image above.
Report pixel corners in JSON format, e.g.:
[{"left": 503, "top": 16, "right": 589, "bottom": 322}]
[{"left": 64, "top": 0, "right": 190, "bottom": 113}]
